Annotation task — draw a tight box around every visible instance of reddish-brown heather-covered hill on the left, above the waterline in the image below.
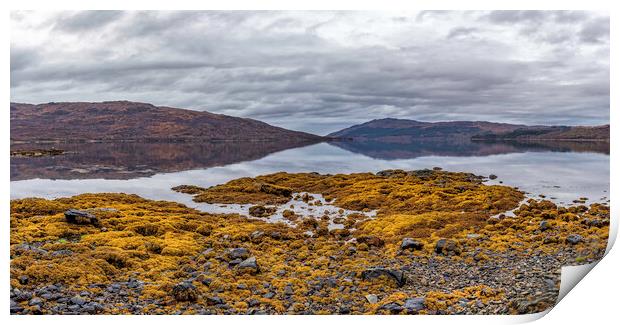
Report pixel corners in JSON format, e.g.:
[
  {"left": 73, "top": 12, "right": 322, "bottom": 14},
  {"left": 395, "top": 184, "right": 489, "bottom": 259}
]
[{"left": 11, "top": 101, "right": 323, "bottom": 142}]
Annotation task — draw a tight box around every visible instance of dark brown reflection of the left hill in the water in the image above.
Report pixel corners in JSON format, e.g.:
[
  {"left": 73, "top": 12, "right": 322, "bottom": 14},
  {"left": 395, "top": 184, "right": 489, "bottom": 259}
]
[{"left": 11, "top": 141, "right": 318, "bottom": 181}]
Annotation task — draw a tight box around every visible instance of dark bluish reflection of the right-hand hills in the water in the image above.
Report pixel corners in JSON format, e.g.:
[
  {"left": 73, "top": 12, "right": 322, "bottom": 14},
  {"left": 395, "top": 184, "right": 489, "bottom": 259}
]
[{"left": 330, "top": 138, "right": 609, "bottom": 160}]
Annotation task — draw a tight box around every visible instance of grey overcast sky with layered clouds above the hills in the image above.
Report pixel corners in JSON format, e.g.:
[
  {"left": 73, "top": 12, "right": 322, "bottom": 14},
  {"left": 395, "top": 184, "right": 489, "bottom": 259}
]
[{"left": 11, "top": 11, "right": 609, "bottom": 134}]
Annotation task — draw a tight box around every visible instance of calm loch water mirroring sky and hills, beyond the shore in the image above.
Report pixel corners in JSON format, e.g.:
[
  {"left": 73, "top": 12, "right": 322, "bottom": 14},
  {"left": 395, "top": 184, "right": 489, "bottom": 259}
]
[{"left": 11, "top": 139, "right": 610, "bottom": 207}]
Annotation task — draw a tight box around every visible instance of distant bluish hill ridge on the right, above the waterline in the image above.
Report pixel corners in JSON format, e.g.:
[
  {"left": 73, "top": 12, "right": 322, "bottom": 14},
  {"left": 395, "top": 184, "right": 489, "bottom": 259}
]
[{"left": 328, "top": 118, "right": 609, "bottom": 143}]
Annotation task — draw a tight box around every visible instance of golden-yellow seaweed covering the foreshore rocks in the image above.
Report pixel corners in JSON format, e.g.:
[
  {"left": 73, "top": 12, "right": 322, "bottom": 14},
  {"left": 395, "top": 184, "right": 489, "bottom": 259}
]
[{"left": 11, "top": 171, "right": 609, "bottom": 314}]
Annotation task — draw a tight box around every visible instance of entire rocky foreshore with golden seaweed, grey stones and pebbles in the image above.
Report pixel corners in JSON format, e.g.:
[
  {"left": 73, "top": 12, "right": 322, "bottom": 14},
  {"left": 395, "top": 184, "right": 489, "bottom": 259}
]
[{"left": 10, "top": 170, "right": 609, "bottom": 314}]
